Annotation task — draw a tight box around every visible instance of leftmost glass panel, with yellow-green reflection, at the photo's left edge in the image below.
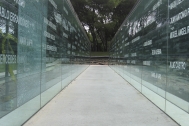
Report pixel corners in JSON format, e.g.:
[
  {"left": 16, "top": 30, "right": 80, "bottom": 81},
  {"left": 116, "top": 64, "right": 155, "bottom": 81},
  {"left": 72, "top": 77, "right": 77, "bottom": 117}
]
[{"left": 0, "top": 1, "right": 18, "bottom": 117}]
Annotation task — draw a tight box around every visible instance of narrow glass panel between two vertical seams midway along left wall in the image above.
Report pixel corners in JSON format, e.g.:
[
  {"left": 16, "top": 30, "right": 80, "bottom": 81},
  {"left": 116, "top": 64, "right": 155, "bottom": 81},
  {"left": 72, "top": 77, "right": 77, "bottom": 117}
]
[{"left": 41, "top": 1, "right": 63, "bottom": 106}]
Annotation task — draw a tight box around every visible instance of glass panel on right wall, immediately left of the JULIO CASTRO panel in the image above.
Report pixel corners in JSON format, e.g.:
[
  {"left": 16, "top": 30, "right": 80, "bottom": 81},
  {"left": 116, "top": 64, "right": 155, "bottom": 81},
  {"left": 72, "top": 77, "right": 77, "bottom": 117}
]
[{"left": 142, "top": 1, "right": 168, "bottom": 97}]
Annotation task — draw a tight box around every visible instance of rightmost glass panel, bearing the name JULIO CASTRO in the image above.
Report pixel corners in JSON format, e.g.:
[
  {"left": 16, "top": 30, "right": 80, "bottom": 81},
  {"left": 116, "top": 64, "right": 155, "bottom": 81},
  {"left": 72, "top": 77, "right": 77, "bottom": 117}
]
[{"left": 166, "top": 0, "right": 189, "bottom": 112}]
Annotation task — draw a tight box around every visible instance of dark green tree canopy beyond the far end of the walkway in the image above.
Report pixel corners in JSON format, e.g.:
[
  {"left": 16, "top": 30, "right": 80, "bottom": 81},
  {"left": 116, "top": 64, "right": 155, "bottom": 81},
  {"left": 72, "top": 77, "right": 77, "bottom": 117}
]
[{"left": 70, "top": 0, "right": 137, "bottom": 51}]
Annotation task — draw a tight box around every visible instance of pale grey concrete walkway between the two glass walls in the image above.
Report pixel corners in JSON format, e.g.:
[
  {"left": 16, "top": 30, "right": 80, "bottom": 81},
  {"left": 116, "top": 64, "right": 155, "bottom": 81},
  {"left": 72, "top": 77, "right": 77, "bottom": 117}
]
[{"left": 24, "top": 66, "right": 178, "bottom": 126}]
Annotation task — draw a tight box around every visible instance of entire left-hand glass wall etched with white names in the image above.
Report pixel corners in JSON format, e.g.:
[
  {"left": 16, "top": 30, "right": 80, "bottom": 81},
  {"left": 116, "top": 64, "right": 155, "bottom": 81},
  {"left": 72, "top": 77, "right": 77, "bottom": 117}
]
[{"left": 0, "top": 0, "right": 90, "bottom": 126}]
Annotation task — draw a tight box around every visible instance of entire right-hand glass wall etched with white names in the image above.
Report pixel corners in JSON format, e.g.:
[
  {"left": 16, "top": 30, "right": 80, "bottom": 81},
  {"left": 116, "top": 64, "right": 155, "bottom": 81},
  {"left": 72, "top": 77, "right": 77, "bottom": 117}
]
[{"left": 109, "top": 0, "right": 189, "bottom": 125}]
